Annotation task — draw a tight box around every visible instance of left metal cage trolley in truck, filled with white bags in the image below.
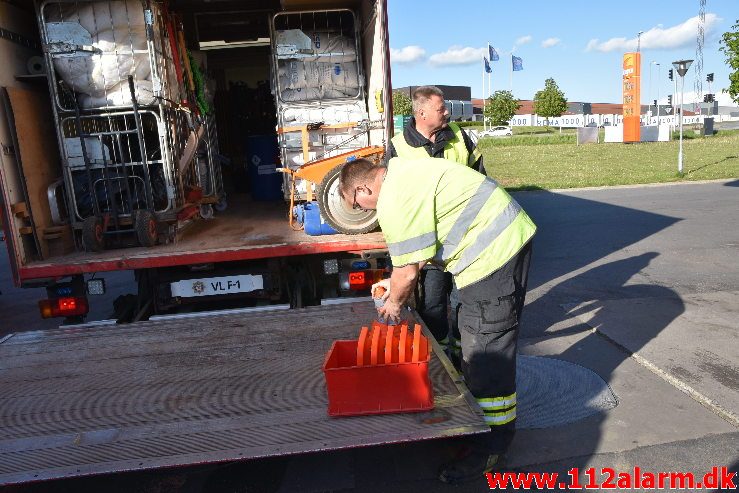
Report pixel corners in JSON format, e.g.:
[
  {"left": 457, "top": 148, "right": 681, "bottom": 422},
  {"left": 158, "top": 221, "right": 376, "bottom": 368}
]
[{"left": 37, "top": 0, "right": 223, "bottom": 251}]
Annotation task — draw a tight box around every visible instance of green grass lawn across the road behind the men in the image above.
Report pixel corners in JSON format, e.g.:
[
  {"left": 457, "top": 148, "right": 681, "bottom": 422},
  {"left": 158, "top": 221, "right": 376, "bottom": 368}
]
[{"left": 479, "top": 131, "right": 739, "bottom": 190}]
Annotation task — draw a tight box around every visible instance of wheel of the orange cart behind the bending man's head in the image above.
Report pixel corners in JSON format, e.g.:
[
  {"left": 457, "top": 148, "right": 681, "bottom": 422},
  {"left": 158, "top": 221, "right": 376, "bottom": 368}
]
[{"left": 317, "top": 164, "right": 378, "bottom": 235}]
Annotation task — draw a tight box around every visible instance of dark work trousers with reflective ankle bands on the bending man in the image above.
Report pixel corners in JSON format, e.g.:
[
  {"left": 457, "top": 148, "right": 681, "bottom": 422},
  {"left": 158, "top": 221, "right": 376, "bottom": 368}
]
[{"left": 459, "top": 242, "right": 531, "bottom": 454}]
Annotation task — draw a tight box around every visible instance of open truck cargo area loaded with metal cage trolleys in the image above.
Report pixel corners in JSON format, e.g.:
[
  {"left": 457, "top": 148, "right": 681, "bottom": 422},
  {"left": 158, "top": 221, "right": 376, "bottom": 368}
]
[{"left": 0, "top": 0, "right": 392, "bottom": 286}]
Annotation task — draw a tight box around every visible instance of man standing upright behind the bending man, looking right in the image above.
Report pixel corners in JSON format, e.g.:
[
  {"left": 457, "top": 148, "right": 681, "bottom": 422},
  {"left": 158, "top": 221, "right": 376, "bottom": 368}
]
[{"left": 388, "top": 86, "right": 485, "bottom": 358}]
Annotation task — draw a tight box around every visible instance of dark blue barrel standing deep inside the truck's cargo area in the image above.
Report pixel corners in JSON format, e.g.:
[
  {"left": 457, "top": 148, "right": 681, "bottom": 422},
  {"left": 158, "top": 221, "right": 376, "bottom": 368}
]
[{"left": 246, "top": 135, "right": 283, "bottom": 201}]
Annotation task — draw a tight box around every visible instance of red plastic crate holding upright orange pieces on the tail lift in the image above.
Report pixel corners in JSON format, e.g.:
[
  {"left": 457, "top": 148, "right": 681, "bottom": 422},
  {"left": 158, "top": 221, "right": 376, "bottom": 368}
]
[{"left": 323, "top": 322, "right": 434, "bottom": 416}]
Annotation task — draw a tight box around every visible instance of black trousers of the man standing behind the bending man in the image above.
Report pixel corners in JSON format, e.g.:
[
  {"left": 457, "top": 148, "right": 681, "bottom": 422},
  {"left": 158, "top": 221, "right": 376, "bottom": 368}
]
[{"left": 418, "top": 264, "right": 459, "bottom": 341}]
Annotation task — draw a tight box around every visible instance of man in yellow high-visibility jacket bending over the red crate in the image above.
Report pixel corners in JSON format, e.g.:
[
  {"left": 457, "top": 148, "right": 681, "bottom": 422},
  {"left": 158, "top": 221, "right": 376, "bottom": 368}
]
[{"left": 339, "top": 158, "right": 536, "bottom": 483}]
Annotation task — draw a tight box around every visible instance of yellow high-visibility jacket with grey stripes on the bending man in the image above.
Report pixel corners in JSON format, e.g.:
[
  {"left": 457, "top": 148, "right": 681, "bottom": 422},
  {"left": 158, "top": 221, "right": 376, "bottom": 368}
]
[{"left": 377, "top": 157, "right": 536, "bottom": 289}]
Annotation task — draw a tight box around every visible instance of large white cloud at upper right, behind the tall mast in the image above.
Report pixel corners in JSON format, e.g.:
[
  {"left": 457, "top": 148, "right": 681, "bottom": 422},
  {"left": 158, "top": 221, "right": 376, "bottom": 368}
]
[{"left": 585, "top": 13, "right": 721, "bottom": 53}]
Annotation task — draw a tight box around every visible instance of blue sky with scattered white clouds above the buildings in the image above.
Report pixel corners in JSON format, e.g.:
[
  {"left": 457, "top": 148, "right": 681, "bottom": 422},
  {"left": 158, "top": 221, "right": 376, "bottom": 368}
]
[{"left": 388, "top": 0, "right": 739, "bottom": 104}]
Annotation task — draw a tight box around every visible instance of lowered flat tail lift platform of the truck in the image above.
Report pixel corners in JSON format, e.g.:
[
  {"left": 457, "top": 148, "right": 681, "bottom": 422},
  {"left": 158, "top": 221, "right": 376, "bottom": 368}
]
[{"left": 0, "top": 299, "right": 489, "bottom": 484}]
